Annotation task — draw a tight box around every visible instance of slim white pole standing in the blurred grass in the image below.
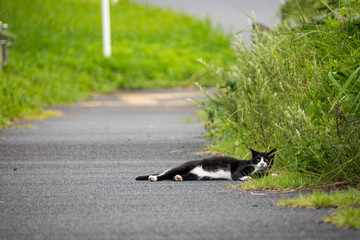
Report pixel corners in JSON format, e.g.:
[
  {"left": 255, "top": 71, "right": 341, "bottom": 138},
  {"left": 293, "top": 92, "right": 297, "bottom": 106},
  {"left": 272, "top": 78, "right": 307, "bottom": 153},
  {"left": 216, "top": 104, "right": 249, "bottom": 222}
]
[{"left": 101, "top": 0, "right": 111, "bottom": 57}]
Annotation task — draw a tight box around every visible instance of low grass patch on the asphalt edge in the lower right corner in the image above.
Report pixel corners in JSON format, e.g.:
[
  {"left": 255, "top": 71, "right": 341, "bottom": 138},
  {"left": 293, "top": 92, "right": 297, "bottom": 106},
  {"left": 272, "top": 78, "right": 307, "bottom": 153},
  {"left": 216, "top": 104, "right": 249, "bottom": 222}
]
[{"left": 278, "top": 188, "right": 360, "bottom": 229}]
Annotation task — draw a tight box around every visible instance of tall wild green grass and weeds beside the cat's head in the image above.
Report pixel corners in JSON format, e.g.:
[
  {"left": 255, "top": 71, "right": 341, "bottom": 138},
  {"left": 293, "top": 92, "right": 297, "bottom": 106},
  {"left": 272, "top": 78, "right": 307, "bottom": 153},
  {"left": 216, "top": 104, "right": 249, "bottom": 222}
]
[{"left": 200, "top": 0, "right": 360, "bottom": 189}]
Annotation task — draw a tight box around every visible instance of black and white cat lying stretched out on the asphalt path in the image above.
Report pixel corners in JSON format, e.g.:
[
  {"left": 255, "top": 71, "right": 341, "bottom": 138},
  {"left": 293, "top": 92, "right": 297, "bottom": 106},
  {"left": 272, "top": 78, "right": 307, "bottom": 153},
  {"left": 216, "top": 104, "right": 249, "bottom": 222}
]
[{"left": 136, "top": 149, "right": 276, "bottom": 182}]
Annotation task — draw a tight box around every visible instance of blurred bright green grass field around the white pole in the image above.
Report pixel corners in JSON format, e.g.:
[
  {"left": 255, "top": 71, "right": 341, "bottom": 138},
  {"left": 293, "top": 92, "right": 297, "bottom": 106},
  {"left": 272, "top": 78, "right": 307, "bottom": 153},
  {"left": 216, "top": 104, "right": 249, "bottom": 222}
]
[{"left": 0, "top": 0, "right": 234, "bottom": 124}]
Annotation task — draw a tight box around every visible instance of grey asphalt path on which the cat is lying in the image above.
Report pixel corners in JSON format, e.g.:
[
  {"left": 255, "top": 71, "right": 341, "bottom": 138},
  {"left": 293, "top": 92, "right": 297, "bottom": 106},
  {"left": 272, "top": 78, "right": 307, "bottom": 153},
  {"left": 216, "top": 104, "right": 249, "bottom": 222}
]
[{"left": 0, "top": 90, "right": 360, "bottom": 240}]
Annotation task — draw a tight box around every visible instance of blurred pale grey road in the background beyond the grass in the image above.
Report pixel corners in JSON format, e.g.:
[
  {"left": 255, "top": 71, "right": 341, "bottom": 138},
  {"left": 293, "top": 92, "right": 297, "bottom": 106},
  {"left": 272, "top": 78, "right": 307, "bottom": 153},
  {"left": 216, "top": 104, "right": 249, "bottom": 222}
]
[{"left": 133, "top": 0, "right": 281, "bottom": 41}]
